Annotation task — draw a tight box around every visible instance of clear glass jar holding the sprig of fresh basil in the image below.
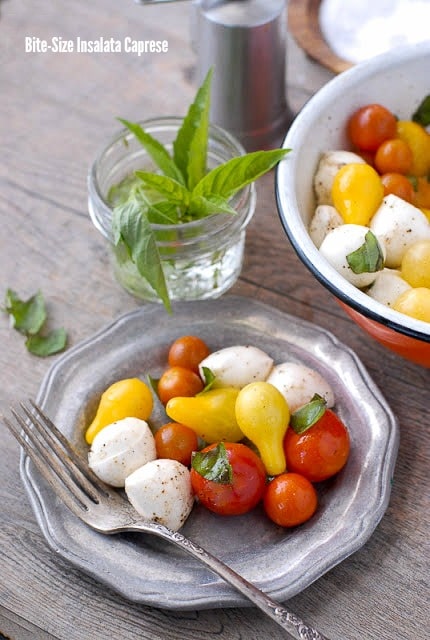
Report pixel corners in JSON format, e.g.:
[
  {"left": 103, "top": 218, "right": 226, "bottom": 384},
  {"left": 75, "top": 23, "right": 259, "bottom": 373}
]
[{"left": 88, "top": 118, "right": 256, "bottom": 301}]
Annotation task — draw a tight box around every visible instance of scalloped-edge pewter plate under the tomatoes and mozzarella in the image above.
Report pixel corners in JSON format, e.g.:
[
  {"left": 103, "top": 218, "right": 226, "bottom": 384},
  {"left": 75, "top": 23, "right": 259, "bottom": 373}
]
[{"left": 21, "top": 296, "right": 398, "bottom": 610}]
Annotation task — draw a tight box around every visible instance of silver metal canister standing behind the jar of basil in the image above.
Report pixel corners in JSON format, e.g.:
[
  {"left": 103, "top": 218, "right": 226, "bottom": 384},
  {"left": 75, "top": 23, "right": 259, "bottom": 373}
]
[{"left": 191, "top": 0, "right": 292, "bottom": 151}]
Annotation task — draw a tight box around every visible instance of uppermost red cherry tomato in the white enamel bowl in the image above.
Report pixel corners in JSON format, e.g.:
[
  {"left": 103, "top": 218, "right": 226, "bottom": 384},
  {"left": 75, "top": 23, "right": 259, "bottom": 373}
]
[{"left": 347, "top": 104, "right": 397, "bottom": 151}]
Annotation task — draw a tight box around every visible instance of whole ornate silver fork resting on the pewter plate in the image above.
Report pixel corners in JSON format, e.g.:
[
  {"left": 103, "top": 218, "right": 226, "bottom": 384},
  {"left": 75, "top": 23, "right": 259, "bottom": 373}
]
[{"left": 2, "top": 400, "right": 328, "bottom": 640}]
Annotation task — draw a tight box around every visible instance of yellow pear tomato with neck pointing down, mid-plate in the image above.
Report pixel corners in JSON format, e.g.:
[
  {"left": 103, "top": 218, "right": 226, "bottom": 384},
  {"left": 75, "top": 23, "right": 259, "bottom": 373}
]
[{"left": 236, "top": 381, "right": 290, "bottom": 476}]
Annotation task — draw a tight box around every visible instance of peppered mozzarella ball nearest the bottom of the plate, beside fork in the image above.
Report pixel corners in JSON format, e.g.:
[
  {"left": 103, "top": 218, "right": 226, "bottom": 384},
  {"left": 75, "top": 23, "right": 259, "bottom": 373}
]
[{"left": 125, "top": 458, "right": 194, "bottom": 531}]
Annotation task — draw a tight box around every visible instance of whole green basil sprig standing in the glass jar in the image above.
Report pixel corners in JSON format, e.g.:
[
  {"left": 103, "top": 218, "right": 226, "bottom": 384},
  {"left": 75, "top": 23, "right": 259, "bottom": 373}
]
[{"left": 109, "top": 69, "right": 289, "bottom": 311}]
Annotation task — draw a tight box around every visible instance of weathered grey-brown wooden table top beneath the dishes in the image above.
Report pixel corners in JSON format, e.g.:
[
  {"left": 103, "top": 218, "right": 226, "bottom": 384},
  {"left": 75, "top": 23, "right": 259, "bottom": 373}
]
[{"left": 0, "top": 0, "right": 430, "bottom": 640}]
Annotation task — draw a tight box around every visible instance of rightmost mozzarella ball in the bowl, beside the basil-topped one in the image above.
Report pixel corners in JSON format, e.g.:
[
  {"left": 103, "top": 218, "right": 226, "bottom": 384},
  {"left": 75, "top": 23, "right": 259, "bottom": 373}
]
[{"left": 370, "top": 194, "right": 430, "bottom": 269}]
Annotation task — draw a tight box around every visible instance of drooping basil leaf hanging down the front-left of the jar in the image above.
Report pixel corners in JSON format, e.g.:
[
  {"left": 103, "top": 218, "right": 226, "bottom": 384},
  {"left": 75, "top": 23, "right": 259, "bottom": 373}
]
[{"left": 112, "top": 199, "right": 172, "bottom": 312}]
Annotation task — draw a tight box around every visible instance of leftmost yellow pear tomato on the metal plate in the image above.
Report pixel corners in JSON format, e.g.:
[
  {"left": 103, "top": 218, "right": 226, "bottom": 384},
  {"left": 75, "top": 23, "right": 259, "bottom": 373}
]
[{"left": 85, "top": 378, "right": 153, "bottom": 444}]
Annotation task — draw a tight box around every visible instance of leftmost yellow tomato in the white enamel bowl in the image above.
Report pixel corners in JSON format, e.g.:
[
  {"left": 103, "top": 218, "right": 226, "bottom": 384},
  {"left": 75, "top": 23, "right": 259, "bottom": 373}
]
[{"left": 332, "top": 162, "right": 384, "bottom": 226}]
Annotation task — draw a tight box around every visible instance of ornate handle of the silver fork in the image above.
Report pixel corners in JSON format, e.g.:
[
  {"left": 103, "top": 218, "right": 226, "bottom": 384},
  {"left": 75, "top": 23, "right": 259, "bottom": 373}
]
[{"left": 128, "top": 522, "right": 329, "bottom": 640}]
